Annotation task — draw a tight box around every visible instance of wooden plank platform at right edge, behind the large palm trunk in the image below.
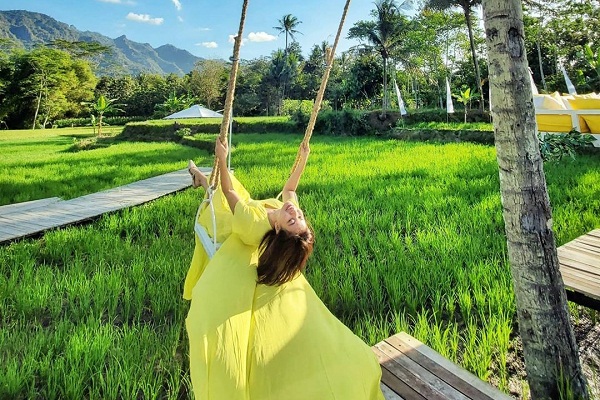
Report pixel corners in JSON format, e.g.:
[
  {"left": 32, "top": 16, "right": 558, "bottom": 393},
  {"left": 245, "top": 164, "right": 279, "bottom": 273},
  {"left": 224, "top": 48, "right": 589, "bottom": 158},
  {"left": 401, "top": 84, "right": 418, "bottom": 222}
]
[{"left": 557, "top": 229, "right": 600, "bottom": 310}]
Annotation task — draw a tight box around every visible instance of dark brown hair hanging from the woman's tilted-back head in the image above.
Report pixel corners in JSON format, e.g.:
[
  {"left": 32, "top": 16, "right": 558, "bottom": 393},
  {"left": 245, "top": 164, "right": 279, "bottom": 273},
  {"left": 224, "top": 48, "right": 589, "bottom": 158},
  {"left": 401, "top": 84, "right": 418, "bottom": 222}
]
[{"left": 257, "top": 226, "right": 314, "bottom": 286}]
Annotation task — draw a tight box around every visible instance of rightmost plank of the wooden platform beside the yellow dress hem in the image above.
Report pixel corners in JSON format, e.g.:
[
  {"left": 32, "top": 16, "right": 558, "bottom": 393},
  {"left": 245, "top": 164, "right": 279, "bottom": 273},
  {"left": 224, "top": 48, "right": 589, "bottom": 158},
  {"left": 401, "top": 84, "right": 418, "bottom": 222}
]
[{"left": 394, "top": 332, "right": 511, "bottom": 400}]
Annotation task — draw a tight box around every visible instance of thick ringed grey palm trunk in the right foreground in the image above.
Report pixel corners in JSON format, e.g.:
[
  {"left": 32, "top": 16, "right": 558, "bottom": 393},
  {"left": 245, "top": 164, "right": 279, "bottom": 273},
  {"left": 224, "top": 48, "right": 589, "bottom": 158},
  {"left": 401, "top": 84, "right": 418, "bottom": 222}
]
[{"left": 483, "top": 0, "right": 588, "bottom": 399}]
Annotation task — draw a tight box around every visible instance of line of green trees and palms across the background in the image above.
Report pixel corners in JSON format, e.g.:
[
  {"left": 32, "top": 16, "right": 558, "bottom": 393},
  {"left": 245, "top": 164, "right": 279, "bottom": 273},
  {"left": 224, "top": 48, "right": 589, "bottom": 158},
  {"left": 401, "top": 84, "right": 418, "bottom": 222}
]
[{"left": 0, "top": 0, "right": 600, "bottom": 128}]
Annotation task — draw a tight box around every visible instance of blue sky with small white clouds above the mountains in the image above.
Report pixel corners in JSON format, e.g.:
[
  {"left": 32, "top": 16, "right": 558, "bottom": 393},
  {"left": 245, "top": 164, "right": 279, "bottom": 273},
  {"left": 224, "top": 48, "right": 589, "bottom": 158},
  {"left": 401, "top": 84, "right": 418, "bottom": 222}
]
[{"left": 0, "top": 0, "right": 374, "bottom": 59}]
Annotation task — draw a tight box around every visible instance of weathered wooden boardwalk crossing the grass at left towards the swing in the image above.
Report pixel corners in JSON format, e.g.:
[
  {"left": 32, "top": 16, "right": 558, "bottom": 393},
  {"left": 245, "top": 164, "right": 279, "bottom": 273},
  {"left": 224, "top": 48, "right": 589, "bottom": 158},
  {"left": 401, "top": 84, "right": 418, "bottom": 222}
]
[{"left": 0, "top": 168, "right": 211, "bottom": 243}]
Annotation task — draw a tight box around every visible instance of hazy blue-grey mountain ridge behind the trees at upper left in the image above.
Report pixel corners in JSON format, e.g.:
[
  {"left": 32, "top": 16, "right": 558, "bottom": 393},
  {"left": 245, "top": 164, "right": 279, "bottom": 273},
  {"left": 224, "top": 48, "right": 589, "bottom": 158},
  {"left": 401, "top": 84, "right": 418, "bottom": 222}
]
[{"left": 0, "top": 10, "right": 202, "bottom": 75}]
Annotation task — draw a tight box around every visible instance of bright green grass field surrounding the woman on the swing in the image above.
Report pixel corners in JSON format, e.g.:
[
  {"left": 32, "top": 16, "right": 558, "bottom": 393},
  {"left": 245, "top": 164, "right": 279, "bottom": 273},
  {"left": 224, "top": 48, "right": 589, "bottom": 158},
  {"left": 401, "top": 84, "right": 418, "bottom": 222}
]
[{"left": 0, "top": 130, "right": 600, "bottom": 399}]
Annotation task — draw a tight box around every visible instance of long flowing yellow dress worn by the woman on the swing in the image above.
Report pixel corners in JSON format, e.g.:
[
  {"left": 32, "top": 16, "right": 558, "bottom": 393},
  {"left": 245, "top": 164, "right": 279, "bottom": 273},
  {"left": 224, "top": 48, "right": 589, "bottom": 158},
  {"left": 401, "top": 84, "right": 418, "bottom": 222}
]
[{"left": 186, "top": 175, "right": 383, "bottom": 400}]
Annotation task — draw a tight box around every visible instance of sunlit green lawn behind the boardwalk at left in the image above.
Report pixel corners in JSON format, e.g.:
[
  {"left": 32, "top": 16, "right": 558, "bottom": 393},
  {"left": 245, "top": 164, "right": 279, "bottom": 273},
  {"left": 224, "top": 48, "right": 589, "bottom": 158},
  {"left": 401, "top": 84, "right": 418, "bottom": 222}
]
[{"left": 0, "top": 127, "right": 208, "bottom": 205}]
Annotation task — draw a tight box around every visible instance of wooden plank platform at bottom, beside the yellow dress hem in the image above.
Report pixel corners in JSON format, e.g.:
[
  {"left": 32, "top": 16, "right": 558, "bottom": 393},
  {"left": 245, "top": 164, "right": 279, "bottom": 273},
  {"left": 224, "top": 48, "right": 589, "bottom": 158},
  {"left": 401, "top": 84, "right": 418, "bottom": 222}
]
[{"left": 372, "top": 332, "right": 511, "bottom": 400}]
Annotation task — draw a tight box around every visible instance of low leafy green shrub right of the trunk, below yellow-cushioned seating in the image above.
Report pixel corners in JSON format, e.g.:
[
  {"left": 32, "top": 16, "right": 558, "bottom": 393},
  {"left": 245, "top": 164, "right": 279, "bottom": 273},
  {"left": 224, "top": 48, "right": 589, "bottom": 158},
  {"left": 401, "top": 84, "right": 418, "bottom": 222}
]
[{"left": 538, "top": 130, "right": 596, "bottom": 162}]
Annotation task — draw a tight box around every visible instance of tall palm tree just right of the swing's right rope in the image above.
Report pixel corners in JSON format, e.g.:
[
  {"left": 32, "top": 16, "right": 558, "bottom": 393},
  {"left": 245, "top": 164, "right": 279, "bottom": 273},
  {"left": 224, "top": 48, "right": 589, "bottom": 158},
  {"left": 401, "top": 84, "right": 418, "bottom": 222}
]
[{"left": 348, "top": 0, "right": 406, "bottom": 115}]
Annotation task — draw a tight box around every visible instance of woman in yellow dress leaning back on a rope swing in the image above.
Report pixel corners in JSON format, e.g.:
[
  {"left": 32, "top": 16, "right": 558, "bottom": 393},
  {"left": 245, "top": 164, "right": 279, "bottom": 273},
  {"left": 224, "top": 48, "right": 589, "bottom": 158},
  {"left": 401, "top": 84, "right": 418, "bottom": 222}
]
[{"left": 184, "top": 139, "right": 383, "bottom": 400}]
